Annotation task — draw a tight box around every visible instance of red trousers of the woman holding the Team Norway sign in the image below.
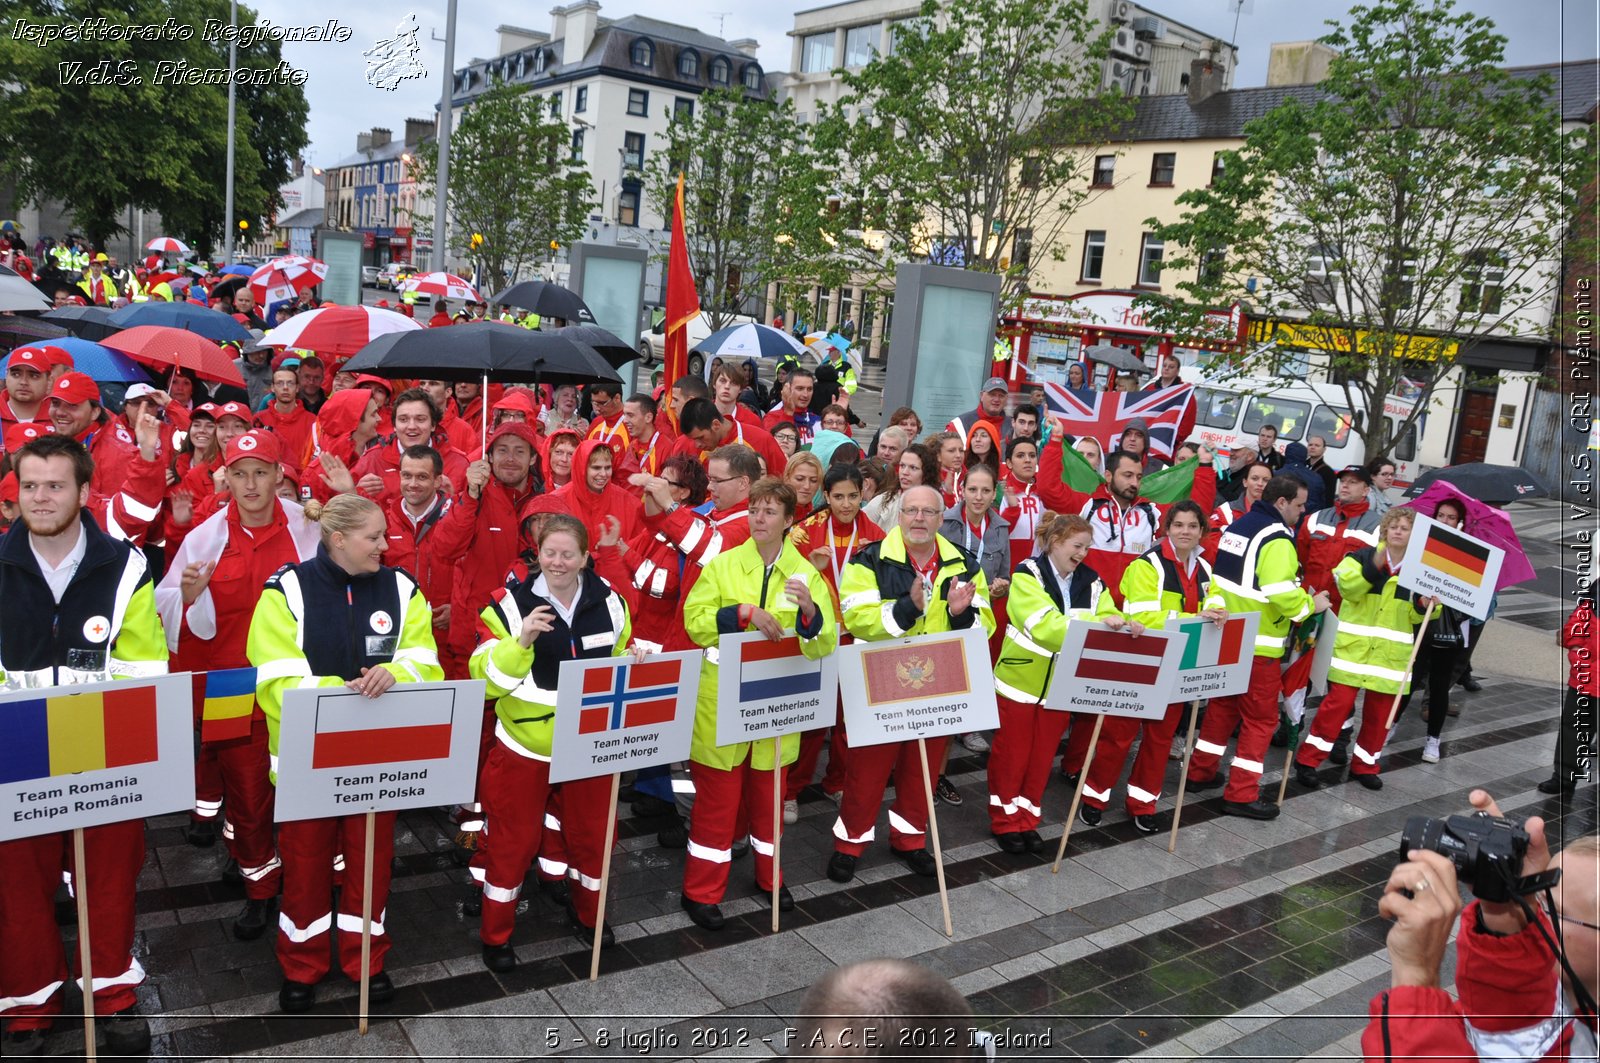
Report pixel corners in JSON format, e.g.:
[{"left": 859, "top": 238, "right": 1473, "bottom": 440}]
[{"left": 472, "top": 741, "right": 611, "bottom": 945}]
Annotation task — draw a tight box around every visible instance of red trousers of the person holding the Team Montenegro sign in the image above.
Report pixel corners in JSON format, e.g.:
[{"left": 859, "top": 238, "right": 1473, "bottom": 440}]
[{"left": 834, "top": 738, "right": 949, "bottom": 856}]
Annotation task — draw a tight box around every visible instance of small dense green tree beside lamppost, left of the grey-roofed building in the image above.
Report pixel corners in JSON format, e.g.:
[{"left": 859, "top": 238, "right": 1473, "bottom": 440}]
[{"left": 416, "top": 85, "right": 592, "bottom": 296}]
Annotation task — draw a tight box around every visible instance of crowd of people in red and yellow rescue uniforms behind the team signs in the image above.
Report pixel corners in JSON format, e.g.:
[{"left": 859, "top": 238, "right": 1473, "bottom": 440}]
[{"left": 0, "top": 303, "right": 1594, "bottom": 1050}]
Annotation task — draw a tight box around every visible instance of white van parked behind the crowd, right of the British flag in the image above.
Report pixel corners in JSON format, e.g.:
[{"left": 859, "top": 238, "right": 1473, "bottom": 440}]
[{"left": 1184, "top": 371, "right": 1422, "bottom": 483}]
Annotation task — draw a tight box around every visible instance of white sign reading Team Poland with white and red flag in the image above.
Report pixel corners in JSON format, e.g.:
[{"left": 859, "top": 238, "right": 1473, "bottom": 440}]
[{"left": 277, "top": 679, "right": 485, "bottom": 821}]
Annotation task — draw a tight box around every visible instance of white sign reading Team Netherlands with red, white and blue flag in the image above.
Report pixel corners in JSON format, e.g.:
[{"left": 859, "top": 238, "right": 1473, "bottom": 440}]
[{"left": 717, "top": 631, "right": 838, "bottom": 746}]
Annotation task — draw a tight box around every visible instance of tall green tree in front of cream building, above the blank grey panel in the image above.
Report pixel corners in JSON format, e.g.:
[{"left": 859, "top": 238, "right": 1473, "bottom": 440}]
[{"left": 816, "top": 0, "right": 1131, "bottom": 296}]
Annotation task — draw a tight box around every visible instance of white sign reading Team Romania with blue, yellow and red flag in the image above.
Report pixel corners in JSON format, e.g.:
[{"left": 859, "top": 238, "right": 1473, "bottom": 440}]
[{"left": 0, "top": 676, "right": 195, "bottom": 842}]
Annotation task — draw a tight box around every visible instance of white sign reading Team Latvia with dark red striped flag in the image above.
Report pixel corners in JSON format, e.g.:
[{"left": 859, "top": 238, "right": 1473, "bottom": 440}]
[{"left": 1043, "top": 621, "right": 1187, "bottom": 720}]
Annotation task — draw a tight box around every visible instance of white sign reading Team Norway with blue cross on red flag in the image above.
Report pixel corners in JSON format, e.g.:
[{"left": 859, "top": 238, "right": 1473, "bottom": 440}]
[{"left": 550, "top": 650, "right": 701, "bottom": 783}]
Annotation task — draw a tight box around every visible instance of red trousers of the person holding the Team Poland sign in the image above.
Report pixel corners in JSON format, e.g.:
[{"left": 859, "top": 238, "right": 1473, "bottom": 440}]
[{"left": 277, "top": 812, "right": 398, "bottom": 985}]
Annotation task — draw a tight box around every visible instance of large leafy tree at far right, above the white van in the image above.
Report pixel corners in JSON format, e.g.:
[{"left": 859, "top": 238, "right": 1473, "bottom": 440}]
[{"left": 1146, "top": 0, "right": 1594, "bottom": 453}]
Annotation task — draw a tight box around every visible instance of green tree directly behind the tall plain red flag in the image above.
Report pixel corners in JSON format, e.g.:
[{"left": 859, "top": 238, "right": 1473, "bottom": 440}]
[{"left": 642, "top": 90, "right": 829, "bottom": 328}]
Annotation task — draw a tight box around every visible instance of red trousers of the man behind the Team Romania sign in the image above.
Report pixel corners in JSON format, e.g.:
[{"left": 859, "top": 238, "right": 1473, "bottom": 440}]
[{"left": 0, "top": 820, "right": 144, "bottom": 1029}]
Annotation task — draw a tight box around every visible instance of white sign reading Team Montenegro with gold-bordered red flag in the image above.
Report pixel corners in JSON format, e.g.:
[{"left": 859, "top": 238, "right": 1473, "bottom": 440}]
[{"left": 837, "top": 626, "right": 1000, "bottom": 746}]
